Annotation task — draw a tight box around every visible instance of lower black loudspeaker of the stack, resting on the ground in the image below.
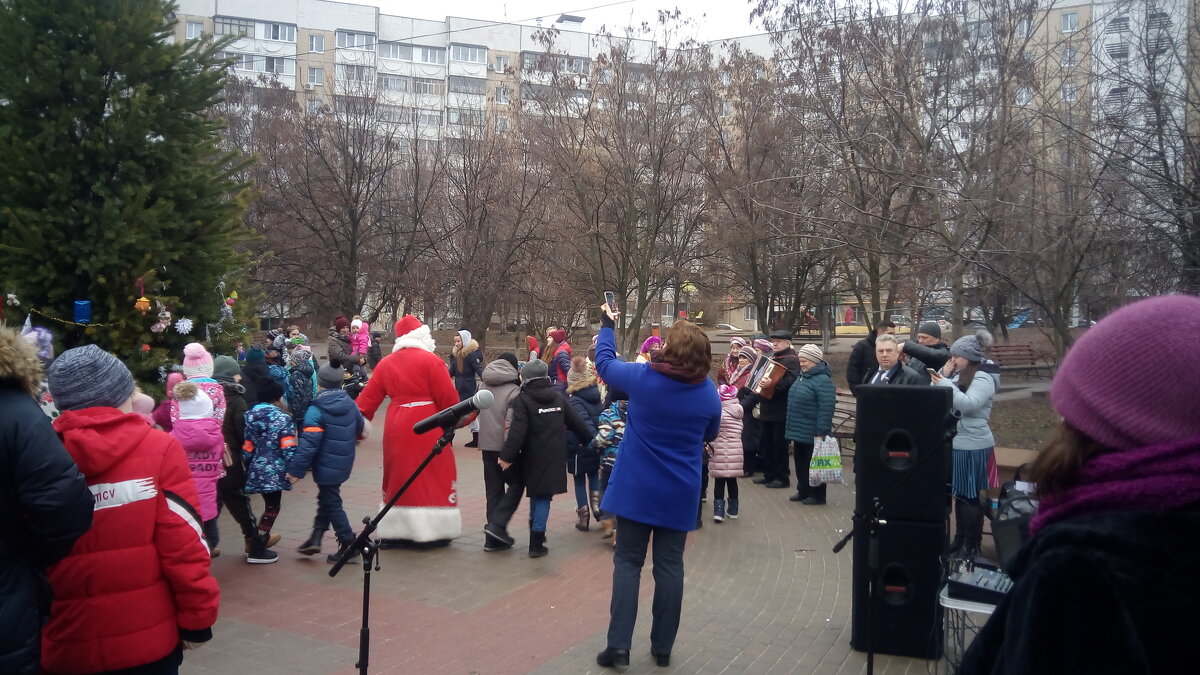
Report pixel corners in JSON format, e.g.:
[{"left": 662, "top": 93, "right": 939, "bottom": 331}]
[{"left": 850, "top": 520, "right": 946, "bottom": 658}]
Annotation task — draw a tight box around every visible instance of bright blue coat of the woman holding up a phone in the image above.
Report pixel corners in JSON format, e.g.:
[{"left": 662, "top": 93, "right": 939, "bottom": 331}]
[{"left": 596, "top": 327, "right": 721, "bottom": 531}]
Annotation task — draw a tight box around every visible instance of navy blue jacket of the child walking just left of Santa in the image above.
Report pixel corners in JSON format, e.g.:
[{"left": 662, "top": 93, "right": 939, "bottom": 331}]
[{"left": 288, "top": 389, "right": 362, "bottom": 485}]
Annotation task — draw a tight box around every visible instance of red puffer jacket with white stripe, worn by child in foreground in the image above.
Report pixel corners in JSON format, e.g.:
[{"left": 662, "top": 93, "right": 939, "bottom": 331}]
[{"left": 42, "top": 407, "right": 220, "bottom": 674}]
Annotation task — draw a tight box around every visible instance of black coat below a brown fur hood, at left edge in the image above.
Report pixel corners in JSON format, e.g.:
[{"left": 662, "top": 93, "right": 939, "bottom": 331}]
[{"left": 0, "top": 381, "right": 94, "bottom": 674}]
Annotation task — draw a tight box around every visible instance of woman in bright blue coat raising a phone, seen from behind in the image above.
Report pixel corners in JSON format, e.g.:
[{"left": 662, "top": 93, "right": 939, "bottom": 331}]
[{"left": 596, "top": 305, "right": 721, "bottom": 668}]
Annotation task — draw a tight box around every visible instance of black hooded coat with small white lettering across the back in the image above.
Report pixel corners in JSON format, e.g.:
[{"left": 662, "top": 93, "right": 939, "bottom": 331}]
[{"left": 500, "top": 377, "right": 588, "bottom": 497}]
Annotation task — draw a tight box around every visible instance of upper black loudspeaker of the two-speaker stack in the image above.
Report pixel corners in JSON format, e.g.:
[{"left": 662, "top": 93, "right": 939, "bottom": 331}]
[{"left": 854, "top": 384, "right": 955, "bottom": 522}]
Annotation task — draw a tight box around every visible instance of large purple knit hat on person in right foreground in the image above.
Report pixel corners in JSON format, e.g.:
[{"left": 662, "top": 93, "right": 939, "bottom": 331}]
[{"left": 1050, "top": 295, "right": 1200, "bottom": 450}]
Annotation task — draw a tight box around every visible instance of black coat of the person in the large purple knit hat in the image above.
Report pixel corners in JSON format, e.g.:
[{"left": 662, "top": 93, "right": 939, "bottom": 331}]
[{"left": 959, "top": 504, "right": 1200, "bottom": 675}]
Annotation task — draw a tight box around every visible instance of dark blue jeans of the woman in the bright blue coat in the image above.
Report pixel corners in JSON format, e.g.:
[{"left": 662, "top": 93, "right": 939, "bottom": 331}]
[{"left": 608, "top": 515, "right": 688, "bottom": 655}]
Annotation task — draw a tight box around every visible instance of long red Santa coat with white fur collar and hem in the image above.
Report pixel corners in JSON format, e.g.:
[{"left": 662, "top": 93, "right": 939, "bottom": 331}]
[{"left": 358, "top": 325, "right": 462, "bottom": 542}]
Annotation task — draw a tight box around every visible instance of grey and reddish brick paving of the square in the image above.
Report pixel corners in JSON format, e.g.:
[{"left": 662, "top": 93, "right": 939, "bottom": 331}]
[{"left": 182, "top": 398, "right": 960, "bottom": 675}]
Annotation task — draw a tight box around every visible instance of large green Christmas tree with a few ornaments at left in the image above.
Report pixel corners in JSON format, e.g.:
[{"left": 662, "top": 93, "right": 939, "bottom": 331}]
[{"left": 0, "top": 0, "right": 248, "bottom": 376}]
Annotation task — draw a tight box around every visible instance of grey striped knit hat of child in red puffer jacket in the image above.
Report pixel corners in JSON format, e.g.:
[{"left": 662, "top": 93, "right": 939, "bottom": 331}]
[{"left": 47, "top": 345, "right": 133, "bottom": 411}]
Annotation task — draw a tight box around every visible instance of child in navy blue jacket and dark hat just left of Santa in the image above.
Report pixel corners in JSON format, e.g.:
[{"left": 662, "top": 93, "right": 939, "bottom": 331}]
[{"left": 288, "top": 364, "right": 366, "bottom": 562}]
